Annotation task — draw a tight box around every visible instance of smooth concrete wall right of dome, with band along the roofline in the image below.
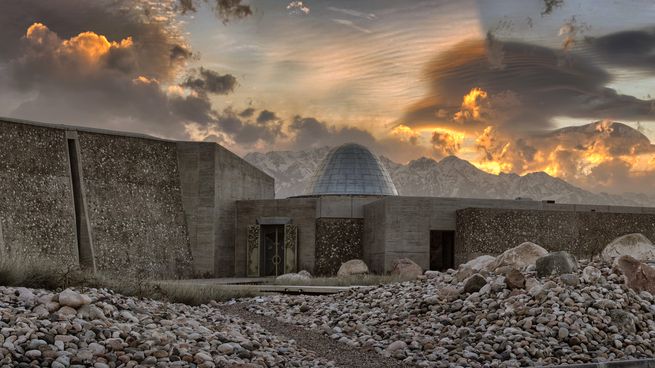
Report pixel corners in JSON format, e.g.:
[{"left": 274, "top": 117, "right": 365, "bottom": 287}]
[{"left": 364, "top": 196, "right": 653, "bottom": 272}]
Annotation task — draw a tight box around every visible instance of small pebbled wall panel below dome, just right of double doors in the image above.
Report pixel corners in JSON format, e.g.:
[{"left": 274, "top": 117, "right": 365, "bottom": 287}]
[{"left": 314, "top": 218, "right": 364, "bottom": 276}]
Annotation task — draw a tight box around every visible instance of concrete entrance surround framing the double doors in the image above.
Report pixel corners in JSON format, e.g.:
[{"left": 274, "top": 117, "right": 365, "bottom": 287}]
[{"left": 235, "top": 198, "right": 317, "bottom": 277}]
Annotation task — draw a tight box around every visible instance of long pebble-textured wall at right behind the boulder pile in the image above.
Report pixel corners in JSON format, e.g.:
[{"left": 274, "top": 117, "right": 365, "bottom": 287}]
[{"left": 455, "top": 208, "right": 655, "bottom": 264}]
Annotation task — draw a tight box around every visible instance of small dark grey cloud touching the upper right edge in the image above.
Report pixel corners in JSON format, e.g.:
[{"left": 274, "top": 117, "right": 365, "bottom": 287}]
[{"left": 586, "top": 29, "right": 655, "bottom": 72}]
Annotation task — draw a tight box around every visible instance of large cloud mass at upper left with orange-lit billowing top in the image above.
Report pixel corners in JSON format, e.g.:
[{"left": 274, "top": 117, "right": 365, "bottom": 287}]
[{"left": 0, "top": 0, "right": 251, "bottom": 139}]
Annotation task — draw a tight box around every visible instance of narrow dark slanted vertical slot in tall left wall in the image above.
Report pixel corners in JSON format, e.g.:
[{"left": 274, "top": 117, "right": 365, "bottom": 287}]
[{"left": 68, "top": 139, "right": 94, "bottom": 270}]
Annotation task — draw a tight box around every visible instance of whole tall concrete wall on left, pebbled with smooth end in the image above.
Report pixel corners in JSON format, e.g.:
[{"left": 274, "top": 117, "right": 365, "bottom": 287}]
[{"left": 0, "top": 118, "right": 272, "bottom": 278}]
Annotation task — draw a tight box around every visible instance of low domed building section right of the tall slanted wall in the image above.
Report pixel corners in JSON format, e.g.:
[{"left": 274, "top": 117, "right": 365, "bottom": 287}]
[{"left": 235, "top": 144, "right": 655, "bottom": 276}]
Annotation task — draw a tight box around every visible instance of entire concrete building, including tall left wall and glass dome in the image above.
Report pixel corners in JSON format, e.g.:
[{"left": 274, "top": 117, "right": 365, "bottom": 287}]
[{"left": 5, "top": 118, "right": 655, "bottom": 278}]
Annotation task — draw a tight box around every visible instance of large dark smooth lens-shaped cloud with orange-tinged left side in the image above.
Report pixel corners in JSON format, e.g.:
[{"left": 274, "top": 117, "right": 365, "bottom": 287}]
[{"left": 404, "top": 38, "right": 655, "bottom": 131}]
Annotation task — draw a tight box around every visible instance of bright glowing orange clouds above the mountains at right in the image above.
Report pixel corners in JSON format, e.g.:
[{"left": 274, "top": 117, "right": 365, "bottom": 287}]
[{"left": 476, "top": 120, "right": 655, "bottom": 196}]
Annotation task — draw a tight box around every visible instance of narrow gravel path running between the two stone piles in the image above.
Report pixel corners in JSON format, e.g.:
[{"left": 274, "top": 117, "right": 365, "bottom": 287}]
[{"left": 220, "top": 303, "right": 415, "bottom": 368}]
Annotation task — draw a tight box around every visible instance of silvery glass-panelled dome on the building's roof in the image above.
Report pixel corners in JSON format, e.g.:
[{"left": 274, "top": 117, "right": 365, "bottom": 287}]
[{"left": 305, "top": 143, "right": 398, "bottom": 195}]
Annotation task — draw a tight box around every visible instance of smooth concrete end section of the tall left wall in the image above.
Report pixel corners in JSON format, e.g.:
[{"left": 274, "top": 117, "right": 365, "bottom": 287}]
[{"left": 177, "top": 142, "right": 275, "bottom": 277}]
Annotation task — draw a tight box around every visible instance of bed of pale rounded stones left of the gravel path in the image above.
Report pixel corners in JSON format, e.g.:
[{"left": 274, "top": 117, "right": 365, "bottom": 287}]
[{"left": 0, "top": 287, "right": 332, "bottom": 368}]
